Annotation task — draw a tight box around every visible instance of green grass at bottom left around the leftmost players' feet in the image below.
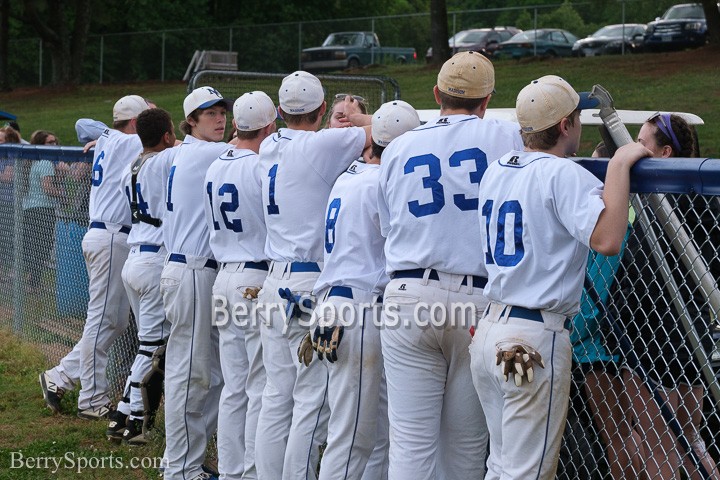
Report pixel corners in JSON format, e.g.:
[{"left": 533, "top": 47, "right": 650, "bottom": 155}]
[{"left": 0, "top": 329, "right": 163, "bottom": 480}]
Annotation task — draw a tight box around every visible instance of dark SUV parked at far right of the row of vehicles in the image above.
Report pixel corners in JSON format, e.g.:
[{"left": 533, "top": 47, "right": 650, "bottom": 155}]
[{"left": 645, "top": 3, "right": 707, "bottom": 51}]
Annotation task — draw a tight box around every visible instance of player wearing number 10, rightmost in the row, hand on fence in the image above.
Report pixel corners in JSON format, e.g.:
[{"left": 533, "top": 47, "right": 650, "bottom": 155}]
[{"left": 470, "top": 75, "right": 650, "bottom": 479}]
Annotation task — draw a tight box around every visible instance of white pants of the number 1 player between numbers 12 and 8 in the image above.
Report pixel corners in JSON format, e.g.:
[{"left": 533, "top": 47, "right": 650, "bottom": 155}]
[{"left": 255, "top": 262, "right": 329, "bottom": 480}]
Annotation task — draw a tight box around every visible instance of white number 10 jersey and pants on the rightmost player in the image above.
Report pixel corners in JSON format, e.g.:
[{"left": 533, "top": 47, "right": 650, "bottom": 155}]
[{"left": 470, "top": 151, "right": 605, "bottom": 479}]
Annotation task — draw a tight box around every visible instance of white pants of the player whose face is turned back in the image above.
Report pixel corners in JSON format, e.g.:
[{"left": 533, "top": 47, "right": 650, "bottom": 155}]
[{"left": 160, "top": 256, "right": 222, "bottom": 480}]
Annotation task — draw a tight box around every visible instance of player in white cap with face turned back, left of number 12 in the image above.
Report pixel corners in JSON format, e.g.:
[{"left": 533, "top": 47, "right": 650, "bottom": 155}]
[{"left": 160, "top": 87, "right": 229, "bottom": 480}]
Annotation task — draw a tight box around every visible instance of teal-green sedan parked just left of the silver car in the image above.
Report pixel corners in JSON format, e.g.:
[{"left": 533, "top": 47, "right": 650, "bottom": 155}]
[{"left": 495, "top": 28, "right": 578, "bottom": 58}]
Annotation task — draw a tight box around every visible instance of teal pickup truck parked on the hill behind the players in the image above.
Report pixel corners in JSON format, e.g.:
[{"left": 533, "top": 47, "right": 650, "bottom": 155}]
[{"left": 300, "top": 32, "right": 417, "bottom": 72}]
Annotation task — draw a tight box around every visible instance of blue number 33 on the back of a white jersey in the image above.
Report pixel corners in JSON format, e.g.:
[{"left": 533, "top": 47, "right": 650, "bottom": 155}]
[{"left": 403, "top": 148, "right": 487, "bottom": 218}]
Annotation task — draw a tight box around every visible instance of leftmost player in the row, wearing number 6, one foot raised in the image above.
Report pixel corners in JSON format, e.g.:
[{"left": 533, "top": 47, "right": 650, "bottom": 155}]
[{"left": 40, "top": 95, "right": 148, "bottom": 419}]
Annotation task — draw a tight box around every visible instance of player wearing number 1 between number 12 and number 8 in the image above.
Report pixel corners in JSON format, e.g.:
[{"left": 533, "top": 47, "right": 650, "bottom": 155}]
[{"left": 255, "top": 71, "right": 370, "bottom": 480}]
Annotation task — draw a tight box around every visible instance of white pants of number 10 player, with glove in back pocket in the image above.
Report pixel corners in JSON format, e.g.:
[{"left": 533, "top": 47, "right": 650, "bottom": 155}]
[{"left": 470, "top": 303, "right": 572, "bottom": 480}]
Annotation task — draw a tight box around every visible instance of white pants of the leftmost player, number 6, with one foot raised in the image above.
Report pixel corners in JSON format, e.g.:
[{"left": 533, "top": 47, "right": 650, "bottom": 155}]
[{"left": 49, "top": 224, "right": 130, "bottom": 410}]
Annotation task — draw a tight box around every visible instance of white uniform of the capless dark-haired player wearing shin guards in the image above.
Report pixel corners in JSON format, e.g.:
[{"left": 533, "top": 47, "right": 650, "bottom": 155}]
[{"left": 118, "top": 149, "right": 176, "bottom": 419}]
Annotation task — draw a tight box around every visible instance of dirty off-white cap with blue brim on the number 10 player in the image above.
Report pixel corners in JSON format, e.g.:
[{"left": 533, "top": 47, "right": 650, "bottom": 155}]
[{"left": 515, "top": 75, "right": 599, "bottom": 132}]
